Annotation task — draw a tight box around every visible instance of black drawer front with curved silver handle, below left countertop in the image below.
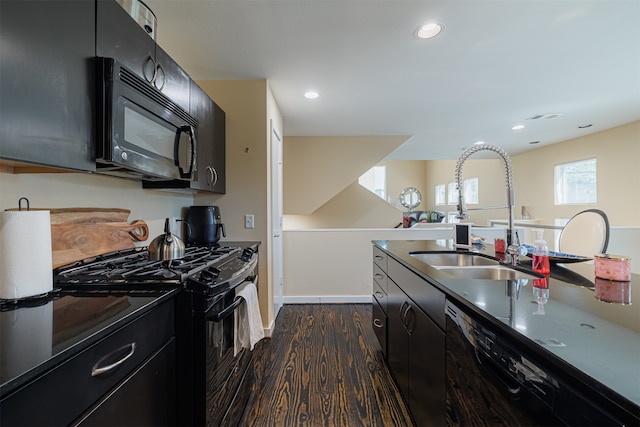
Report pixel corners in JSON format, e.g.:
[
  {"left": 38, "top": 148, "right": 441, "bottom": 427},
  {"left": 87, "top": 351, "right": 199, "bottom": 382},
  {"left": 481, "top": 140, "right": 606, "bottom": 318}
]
[{"left": 0, "top": 300, "right": 174, "bottom": 425}]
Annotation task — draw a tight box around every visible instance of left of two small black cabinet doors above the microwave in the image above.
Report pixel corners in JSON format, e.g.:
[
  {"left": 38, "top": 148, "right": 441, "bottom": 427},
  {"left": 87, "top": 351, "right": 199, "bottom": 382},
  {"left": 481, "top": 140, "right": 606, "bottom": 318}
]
[{"left": 95, "top": 0, "right": 156, "bottom": 82}]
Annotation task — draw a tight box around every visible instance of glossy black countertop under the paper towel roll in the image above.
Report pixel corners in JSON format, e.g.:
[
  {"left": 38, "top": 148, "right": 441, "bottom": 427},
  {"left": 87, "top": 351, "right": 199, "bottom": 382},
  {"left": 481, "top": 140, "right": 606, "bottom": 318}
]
[{"left": 0, "top": 288, "right": 179, "bottom": 398}]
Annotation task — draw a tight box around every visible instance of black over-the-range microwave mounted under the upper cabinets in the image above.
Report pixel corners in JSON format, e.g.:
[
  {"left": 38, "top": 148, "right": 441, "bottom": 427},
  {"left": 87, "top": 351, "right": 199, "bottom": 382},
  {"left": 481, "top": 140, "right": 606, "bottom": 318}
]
[{"left": 96, "top": 58, "right": 198, "bottom": 181}]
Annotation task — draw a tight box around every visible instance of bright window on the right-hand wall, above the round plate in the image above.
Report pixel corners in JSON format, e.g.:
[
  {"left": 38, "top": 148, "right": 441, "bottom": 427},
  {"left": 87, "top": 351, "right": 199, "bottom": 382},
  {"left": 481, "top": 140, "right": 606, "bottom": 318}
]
[{"left": 554, "top": 159, "right": 598, "bottom": 205}]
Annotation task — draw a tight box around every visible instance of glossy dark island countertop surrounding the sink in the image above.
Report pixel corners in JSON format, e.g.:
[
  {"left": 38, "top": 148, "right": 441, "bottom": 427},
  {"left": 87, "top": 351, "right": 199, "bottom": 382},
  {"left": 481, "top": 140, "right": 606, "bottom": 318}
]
[{"left": 374, "top": 240, "right": 640, "bottom": 419}]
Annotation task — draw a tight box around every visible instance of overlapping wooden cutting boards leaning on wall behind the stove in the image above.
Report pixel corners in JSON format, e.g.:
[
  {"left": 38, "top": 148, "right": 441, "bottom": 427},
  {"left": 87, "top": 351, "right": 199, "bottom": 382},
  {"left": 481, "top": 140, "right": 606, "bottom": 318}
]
[{"left": 5, "top": 208, "right": 149, "bottom": 268}]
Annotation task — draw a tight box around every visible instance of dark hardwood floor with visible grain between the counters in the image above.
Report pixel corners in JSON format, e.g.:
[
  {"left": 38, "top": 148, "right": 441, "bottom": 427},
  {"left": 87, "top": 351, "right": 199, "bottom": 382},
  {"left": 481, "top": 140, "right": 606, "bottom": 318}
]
[{"left": 242, "top": 304, "right": 413, "bottom": 427}]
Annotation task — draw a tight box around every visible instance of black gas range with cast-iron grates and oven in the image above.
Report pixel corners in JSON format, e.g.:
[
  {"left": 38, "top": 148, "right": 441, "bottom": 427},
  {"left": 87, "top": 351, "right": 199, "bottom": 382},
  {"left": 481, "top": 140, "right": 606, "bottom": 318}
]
[{"left": 54, "top": 242, "right": 259, "bottom": 426}]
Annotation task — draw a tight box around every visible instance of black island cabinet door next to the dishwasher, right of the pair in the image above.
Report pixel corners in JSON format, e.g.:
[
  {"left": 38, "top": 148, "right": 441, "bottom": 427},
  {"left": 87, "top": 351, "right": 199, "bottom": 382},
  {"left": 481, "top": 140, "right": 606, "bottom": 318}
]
[{"left": 407, "top": 303, "right": 446, "bottom": 426}]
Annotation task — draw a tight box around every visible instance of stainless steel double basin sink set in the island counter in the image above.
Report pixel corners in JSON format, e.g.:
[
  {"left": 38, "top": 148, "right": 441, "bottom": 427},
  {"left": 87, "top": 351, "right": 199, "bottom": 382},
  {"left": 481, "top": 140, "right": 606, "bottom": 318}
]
[{"left": 409, "top": 252, "right": 538, "bottom": 280}]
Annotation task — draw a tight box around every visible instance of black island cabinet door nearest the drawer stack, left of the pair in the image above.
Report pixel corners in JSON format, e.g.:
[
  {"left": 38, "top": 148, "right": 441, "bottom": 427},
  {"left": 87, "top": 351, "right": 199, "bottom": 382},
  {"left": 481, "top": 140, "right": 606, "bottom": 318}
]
[{"left": 387, "top": 280, "right": 409, "bottom": 403}]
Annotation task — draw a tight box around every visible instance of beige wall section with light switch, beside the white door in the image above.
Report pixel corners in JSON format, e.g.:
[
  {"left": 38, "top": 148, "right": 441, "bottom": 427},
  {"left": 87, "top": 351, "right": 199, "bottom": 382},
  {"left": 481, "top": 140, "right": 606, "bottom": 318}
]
[{"left": 189, "top": 80, "right": 283, "bottom": 327}]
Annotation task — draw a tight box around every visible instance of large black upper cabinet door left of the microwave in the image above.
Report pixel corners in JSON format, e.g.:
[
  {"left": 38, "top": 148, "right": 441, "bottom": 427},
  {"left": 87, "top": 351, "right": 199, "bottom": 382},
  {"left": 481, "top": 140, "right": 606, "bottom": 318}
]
[{"left": 0, "top": 0, "right": 95, "bottom": 171}]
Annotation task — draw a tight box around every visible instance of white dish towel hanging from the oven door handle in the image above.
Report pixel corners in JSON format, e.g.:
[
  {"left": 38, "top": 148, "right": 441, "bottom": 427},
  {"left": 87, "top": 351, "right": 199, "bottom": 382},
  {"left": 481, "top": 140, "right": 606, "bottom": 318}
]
[{"left": 233, "top": 282, "right": 264, "bottom": 356}]
